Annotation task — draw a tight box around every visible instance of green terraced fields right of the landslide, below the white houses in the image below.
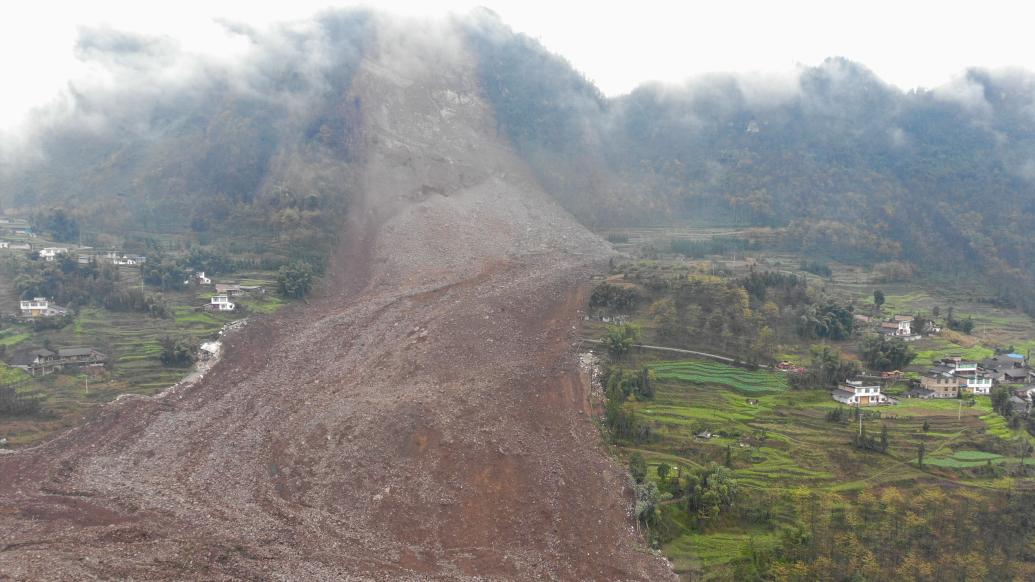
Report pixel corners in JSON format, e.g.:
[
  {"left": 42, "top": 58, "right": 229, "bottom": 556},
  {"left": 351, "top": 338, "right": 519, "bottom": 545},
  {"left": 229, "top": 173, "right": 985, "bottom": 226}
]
[{"left": 619, "top": 354, "right": 1027, "bottom": 580}]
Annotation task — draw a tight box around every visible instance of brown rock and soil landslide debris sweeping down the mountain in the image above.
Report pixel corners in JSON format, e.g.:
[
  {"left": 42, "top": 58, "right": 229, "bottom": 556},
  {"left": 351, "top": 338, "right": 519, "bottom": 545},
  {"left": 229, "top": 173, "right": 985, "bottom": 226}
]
[{"left": 0, "top": 18, "right": 672, "bottom": 580}]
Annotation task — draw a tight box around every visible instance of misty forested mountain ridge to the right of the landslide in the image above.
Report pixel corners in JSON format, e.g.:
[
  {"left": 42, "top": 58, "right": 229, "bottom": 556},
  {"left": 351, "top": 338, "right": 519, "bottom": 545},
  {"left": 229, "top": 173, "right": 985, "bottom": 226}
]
[{"left": 471, "top": 10, "right": 1035, "bottom": 311}]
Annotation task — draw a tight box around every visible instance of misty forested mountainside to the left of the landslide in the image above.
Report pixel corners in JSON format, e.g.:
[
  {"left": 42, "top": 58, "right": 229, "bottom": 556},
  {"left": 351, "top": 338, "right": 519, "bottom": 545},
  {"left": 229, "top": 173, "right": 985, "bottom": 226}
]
[{"left": 0, "top": 11, "right": 373, "bottom": 260}]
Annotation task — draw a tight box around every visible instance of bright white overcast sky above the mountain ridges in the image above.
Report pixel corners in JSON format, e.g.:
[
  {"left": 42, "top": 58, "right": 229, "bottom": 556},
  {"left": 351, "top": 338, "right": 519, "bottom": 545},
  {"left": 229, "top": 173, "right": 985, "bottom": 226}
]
[{"left": 0, "top": 0, "right": 1035, "bottom": 128}]
